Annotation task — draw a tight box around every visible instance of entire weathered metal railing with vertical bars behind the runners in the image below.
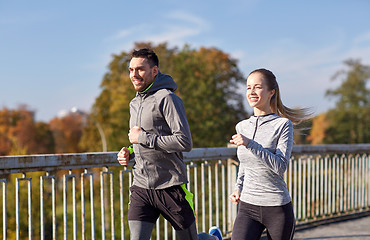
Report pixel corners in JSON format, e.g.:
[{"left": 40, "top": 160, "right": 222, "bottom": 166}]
[{"left": 0, "top": 144, "right": 370, "bottom": 240}]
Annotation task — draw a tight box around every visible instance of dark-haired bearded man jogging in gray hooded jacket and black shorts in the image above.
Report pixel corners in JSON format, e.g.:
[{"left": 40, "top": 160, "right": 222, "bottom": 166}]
[{"left": 118, "top": 48, "right": 197, "bottom": 240}]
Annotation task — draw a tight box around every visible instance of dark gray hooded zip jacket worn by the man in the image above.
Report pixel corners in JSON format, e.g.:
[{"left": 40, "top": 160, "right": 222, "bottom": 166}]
[{"left": 130, "top": 72, "right": 192, "bottom": 189}]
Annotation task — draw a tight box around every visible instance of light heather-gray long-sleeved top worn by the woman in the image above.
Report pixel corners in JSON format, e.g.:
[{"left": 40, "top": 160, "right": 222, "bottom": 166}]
[{"left": 236, "top": 113, "right": 294, "bottom": 206}]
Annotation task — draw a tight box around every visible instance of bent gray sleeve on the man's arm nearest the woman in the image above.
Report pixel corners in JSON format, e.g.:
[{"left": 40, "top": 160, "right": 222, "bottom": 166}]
[{"left": 139, "top": 94, "right": 193, "bottom": 153}]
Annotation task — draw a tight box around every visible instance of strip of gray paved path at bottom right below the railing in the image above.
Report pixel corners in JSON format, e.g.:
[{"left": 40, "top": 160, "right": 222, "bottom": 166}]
[{"left": 294, "top": 216, "right": 370, "bottom": 240}]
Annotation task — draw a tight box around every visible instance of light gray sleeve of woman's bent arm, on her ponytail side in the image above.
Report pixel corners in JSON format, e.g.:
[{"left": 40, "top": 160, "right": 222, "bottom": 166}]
[{"left": 247, "top": 120, "right": 294, "bottom": 175}]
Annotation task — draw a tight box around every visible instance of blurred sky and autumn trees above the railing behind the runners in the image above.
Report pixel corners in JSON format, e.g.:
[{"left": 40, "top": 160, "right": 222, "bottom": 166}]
[{"left": 0, "top": 0, "right": 370, "bottom": 155}]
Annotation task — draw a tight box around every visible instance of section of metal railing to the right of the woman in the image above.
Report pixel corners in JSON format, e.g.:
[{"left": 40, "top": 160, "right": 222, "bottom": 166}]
[{"left": 285, "top": 144, "right": 370, "bottom": 228}]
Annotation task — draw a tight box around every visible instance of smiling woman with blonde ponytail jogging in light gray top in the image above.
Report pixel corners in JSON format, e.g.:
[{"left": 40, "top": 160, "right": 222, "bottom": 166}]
[{"left": 230, "top": 69, "right": 309, "bottom": 240}]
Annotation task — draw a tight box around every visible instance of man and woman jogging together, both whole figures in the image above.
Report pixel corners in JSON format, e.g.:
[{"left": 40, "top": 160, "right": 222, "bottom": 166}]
[{"left": 117, "top": 48, "right": 306, "bottom": 240}]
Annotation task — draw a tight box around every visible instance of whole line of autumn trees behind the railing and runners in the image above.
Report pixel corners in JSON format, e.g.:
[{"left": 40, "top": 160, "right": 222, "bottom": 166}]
[{"left": 0, "top": 47, "right": 370, "bottom": 155}]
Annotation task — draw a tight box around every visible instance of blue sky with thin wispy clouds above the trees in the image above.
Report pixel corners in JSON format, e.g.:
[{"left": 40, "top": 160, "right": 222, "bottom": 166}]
[{"left": 0, "top": 0, "right": 370, "bottom": 121}]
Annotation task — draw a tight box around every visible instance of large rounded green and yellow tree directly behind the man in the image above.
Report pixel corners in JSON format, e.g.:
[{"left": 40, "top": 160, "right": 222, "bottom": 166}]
[{"left": 81, "top": 43, "right": 247, "bottom": 151}]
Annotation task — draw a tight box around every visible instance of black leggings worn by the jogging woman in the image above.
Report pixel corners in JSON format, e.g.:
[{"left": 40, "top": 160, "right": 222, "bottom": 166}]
[{"left": 231, "top": 202, "right": 295, "bottom": 240}]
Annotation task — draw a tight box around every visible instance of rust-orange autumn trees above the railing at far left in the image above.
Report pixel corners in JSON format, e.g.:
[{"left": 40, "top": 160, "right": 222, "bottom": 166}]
[{"left": 0, "top": 105, "right": 84, "bottom": 156}]
